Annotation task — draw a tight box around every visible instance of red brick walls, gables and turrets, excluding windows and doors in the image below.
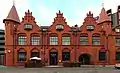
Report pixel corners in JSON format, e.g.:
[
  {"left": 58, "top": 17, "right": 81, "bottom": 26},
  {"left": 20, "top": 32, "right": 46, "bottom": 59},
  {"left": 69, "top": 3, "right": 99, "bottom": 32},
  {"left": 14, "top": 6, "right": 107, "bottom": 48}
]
[{"left": 3, "top": 6, "right": 120, "bottom": 66}]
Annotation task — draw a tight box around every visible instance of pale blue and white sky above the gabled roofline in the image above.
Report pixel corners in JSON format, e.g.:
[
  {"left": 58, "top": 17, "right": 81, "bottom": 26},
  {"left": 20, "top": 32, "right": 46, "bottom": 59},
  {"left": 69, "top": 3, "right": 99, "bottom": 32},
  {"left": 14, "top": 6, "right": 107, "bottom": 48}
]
[{"left": 0, "top": 0, "right": 120, "bottom": 29}]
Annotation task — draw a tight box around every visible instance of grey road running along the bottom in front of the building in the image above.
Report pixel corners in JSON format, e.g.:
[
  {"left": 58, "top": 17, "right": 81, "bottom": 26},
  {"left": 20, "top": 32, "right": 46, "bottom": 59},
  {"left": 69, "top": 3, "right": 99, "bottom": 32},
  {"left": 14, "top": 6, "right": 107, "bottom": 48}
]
[{"left": 0, "top": 67, "right": 120, "bottom": 73}]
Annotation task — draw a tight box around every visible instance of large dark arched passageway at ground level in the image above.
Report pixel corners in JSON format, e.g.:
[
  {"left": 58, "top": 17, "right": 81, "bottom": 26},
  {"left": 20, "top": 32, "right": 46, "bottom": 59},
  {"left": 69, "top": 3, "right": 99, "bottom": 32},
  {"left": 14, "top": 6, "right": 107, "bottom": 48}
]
[{"left": 79, "top": 54, "right": 90, "bottom": 65}]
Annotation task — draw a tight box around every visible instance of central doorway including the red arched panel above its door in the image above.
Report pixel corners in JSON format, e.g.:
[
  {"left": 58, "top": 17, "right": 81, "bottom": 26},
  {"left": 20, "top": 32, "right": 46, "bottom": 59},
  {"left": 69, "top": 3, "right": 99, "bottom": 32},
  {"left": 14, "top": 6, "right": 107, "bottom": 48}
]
[{"left": 49, "top": 49, "right": 58, "bottom": 65}]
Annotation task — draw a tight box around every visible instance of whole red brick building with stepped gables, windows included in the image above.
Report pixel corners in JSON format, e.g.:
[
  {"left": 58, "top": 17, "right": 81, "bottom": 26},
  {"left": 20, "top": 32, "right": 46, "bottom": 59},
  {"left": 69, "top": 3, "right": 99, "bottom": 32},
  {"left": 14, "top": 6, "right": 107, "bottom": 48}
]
[{"left": 3, "top": 5, "right": 120, "bottom": 66}]
